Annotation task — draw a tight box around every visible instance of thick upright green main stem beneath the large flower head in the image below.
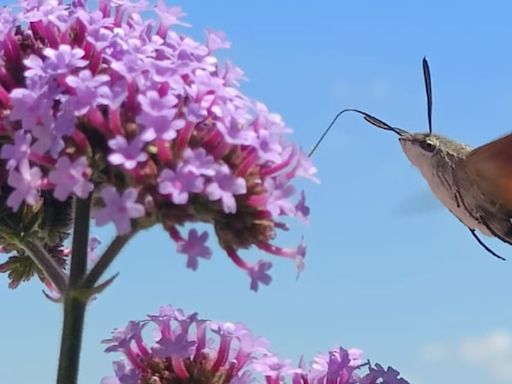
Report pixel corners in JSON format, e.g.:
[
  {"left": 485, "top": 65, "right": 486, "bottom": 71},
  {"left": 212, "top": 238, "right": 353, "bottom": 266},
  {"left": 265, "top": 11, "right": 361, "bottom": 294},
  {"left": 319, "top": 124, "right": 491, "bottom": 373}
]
[{"left": 57, "top": 198, "right": 91, "bottom": 384}]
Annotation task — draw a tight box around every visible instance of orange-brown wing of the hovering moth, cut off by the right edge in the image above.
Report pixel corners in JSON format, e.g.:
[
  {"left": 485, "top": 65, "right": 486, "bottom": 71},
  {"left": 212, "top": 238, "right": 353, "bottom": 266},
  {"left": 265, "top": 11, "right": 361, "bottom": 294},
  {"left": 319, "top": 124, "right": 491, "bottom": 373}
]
[{"left": 463, "top": 134, "right": 512, "bottom": 211}]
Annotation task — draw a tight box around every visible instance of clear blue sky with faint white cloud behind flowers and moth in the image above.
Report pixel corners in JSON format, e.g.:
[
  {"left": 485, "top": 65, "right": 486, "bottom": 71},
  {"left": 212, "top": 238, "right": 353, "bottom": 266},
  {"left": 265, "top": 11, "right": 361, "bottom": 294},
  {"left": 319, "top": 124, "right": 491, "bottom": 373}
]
[{"left": 0, "top": 0, "right": 512, "bottom": 384}]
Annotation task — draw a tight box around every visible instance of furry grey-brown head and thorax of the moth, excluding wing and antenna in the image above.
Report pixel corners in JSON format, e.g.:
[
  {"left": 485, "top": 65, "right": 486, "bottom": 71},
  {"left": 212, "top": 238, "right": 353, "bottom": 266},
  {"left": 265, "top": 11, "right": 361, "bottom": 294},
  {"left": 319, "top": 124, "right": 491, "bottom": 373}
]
[{"left": 399, "top": 134, "right": 491, "bottom": 235}]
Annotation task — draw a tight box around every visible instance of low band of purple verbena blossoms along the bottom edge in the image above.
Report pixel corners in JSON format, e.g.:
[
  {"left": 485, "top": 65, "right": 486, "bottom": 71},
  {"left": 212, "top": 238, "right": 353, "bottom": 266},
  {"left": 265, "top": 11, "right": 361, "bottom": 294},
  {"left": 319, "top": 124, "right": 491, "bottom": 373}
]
[{"left": 101, "top": 306, "right": 408, "bottom": 384}]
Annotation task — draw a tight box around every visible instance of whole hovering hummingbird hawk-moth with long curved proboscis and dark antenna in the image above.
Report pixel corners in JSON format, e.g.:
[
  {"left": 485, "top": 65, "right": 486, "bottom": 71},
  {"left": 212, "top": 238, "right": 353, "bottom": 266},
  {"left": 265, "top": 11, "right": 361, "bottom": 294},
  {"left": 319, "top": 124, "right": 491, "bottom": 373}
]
[{"left": 309, "top": 58, "right": 512, "bottom": 260}]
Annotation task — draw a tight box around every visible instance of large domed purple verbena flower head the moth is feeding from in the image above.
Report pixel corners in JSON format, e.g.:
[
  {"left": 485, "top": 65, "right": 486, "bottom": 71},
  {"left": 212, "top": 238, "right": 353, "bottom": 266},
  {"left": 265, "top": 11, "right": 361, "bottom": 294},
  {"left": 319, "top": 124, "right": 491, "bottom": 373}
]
[{"left": 0, "top": 0, "right": 315, "bottom": 290}]
